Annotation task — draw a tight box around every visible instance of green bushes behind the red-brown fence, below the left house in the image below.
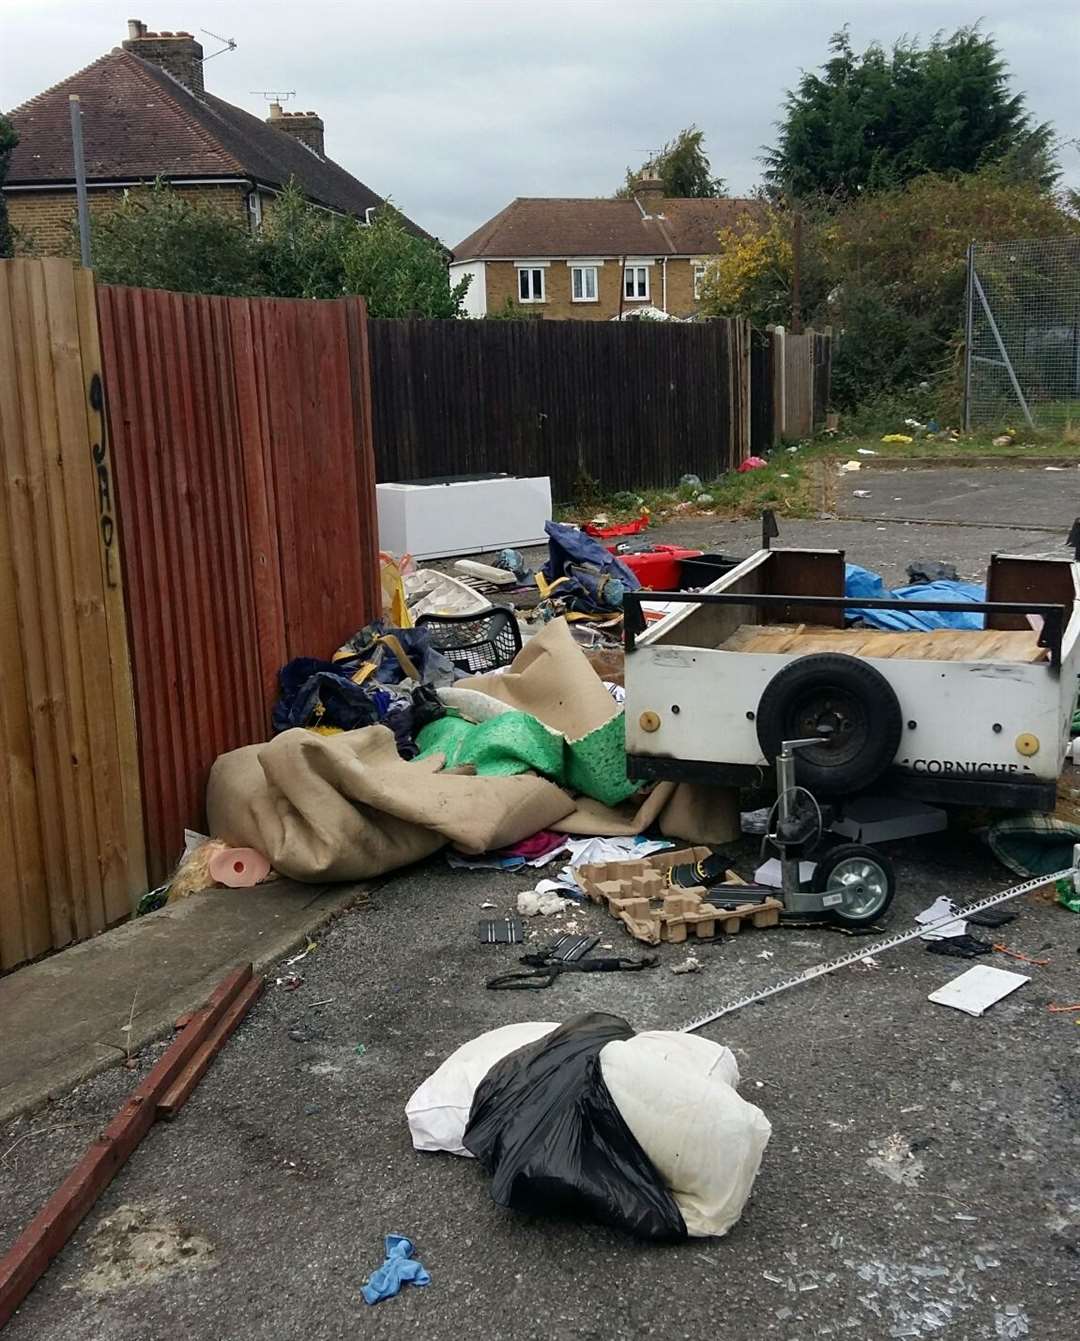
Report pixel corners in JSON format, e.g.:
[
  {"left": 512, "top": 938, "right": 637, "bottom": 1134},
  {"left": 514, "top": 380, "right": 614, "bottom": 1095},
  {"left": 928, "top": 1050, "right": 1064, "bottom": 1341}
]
[{"left": 93, "top": 182, "right": 468, "bottom": 316}]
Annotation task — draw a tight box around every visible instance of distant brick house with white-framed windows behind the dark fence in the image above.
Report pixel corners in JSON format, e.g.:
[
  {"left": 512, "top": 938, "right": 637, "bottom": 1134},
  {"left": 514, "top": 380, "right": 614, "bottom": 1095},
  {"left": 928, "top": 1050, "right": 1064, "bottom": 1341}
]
[{"left": 449, "top": 178, "right": 757, "bottom": 320}]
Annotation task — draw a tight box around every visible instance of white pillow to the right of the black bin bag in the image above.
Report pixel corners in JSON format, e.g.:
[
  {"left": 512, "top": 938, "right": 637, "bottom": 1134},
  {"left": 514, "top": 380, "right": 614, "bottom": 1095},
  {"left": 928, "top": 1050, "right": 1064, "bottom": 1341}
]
[{"left": 600, "top": 1030, "right": 773, "bottom": 1238}]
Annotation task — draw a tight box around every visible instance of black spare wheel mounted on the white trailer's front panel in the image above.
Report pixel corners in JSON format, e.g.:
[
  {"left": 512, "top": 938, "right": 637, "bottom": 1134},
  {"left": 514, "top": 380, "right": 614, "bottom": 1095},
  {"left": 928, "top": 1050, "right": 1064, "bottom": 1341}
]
[{"left": 757, "top": 652, "right": 903, "bottom": 797}]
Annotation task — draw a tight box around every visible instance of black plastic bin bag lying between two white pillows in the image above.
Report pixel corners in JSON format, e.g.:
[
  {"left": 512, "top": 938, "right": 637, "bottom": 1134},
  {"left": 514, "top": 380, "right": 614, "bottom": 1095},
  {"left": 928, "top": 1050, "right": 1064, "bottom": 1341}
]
[{"left": 464, "top": 1012, "right": 687, "bottom": 1240}]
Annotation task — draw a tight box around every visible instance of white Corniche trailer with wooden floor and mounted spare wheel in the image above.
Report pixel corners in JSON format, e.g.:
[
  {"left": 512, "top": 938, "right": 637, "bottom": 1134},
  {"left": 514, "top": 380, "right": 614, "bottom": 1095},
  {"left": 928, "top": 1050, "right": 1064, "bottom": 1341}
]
[{"left": 624, "top": 547, "right": 1080, "bottom": 921}]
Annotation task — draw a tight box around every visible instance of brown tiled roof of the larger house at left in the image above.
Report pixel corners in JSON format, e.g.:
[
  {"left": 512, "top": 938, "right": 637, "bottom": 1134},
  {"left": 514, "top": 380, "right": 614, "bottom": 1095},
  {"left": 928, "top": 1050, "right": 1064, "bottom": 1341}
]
[{"left": 8, "top": 48, "right": 427, "bottom": 236}]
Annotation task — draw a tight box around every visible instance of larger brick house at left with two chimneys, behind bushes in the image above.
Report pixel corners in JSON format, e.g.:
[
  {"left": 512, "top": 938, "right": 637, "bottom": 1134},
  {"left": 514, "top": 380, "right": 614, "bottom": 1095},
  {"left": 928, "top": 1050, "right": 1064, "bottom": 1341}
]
[{"left": 4, "top": 19, "right": 428, "bottom": 253}]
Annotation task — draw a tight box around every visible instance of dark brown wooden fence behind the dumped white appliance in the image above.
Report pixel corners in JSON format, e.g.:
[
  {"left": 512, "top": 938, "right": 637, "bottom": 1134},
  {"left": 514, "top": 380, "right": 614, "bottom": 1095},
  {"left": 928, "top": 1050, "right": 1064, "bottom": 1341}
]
[{"left": 368, "top": 320, "right": 750, "bottom": 499}]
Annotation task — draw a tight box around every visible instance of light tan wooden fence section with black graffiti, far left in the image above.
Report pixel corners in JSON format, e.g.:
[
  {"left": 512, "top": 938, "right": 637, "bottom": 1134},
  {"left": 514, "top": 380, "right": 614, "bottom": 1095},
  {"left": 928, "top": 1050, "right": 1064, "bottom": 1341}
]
[{"left": 0, "top": 260, "right": 146, "bottom": 968}]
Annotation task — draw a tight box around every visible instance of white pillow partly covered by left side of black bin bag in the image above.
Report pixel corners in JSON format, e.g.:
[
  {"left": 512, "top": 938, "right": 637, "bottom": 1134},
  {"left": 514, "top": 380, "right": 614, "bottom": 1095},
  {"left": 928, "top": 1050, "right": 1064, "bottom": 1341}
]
[{"left": 405, "top": 1022, "right": 558, "bottom": 1159}]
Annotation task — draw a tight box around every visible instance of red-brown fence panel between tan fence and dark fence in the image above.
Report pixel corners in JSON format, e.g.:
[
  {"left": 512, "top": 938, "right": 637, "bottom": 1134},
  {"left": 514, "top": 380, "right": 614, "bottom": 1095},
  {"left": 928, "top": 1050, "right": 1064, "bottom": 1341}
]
[{"left": 98, "top": 286, "right": 378, "bottom": 882}]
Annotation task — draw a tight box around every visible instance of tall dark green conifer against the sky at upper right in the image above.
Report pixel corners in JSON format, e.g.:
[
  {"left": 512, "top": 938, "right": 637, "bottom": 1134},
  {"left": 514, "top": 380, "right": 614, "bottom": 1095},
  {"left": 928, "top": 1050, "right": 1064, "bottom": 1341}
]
[{"left": 763, "top": 27, "right": 1059, "bottom": 200}]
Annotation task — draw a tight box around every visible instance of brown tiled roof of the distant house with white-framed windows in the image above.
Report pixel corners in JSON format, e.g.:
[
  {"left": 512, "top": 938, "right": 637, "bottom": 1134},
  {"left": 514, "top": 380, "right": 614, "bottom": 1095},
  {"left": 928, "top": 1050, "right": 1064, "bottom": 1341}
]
[{"left": 453, "top": 197, "right": 758, "bottom": 261}]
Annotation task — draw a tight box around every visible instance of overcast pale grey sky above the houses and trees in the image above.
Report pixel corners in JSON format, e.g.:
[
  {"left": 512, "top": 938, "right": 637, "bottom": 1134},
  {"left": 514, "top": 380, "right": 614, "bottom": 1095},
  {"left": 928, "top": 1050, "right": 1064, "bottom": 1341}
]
[{"left": 0, "top": 0, "right": 1080, "bottom": 245}]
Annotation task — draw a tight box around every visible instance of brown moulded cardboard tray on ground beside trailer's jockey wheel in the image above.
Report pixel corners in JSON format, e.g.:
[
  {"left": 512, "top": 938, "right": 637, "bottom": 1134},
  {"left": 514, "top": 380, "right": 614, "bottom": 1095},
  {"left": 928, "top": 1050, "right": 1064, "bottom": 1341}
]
[{"left": 576, "top": 848, "right": 784, "bottom": 945}]
